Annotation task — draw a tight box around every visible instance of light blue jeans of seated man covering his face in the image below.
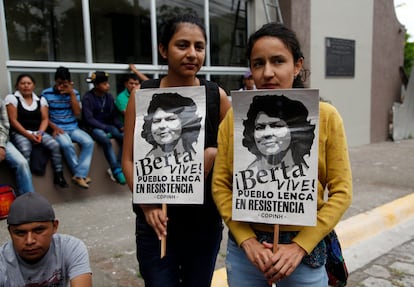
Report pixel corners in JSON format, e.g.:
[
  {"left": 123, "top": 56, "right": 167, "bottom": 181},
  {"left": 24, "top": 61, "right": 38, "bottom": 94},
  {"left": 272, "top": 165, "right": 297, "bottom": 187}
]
[{"left": 55, "top": 129, "right": 94, "bottom": 178}]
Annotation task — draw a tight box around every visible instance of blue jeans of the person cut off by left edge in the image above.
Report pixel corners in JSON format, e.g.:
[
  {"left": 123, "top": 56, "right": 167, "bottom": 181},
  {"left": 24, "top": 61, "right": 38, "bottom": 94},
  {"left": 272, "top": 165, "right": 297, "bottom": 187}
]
[{"left": 6, "top": 142, "right": 35, "bottom": 195}]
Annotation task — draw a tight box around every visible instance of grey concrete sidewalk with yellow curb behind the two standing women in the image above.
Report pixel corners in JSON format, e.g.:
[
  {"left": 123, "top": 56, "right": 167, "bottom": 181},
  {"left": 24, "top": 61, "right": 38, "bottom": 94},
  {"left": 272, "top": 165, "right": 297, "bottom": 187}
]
[{"left": 0, "top": 140, "right": 414, "bottom": 287}]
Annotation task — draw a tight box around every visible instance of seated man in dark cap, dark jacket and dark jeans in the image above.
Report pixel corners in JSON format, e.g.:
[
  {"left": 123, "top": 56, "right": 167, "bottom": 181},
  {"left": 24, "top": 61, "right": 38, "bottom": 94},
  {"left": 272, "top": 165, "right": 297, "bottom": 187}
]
[{"left": 82, "top": 71, "right": 126, "bottom": 184}]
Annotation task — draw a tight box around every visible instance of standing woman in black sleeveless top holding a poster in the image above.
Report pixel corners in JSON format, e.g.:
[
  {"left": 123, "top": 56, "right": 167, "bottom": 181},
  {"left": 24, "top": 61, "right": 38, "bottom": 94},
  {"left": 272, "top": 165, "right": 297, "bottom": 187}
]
[{"left": 122, "top": 12, "right": 231, "bottom": 287}]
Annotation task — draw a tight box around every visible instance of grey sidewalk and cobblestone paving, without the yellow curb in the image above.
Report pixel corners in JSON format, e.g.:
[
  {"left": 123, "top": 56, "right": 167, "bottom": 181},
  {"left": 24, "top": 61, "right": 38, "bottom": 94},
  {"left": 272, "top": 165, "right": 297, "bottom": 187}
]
[{"left": 0, "top": 140, "right": 414, "bottom": 287}]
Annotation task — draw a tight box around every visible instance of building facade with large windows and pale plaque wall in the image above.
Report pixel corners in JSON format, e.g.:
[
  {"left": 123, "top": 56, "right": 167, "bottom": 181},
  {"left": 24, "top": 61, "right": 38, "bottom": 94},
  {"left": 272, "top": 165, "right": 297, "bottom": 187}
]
[{"left": 0, "top": 0, "right": 404, "bottom": 146}]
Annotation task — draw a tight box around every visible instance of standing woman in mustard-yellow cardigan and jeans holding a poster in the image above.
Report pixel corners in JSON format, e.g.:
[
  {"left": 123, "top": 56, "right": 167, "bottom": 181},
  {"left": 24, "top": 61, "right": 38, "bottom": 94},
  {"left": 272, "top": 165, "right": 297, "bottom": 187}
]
[{"left": 212, "top": 23, "right": 352, "bottom": 287}]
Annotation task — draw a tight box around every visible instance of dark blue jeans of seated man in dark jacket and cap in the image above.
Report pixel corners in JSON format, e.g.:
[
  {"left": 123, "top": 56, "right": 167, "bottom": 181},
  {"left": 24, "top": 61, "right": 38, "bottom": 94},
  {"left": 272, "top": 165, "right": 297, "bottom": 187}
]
[{"left": 92, "top": 126, "right": 124, "bottom": 171}]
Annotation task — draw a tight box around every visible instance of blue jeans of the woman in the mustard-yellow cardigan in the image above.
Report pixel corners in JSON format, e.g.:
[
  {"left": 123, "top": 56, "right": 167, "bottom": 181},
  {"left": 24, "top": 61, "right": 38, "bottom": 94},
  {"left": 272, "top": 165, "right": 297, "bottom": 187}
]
[{"left": 226, "top": 238, "right": 328, "bottom": 287}]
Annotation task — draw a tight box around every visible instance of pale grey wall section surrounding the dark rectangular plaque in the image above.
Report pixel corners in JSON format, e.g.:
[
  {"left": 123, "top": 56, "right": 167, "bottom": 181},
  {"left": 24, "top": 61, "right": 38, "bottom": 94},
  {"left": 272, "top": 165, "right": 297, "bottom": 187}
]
[{"left": 310, "top": 0, "right": 374, "bottom": 146}]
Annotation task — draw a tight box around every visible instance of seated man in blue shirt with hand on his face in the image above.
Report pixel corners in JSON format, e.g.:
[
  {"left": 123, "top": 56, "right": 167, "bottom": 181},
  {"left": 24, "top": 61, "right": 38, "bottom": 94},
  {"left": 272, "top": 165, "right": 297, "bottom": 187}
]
[{"left": 42, "top": 67, "right": 94, "bottom": 188}]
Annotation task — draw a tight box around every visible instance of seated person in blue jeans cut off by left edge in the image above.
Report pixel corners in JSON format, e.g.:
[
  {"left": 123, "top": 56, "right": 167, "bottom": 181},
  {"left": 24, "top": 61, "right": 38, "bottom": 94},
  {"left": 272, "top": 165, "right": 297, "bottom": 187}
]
[{"left": 0, "top": 99, "right": 35, "bottom": 195}]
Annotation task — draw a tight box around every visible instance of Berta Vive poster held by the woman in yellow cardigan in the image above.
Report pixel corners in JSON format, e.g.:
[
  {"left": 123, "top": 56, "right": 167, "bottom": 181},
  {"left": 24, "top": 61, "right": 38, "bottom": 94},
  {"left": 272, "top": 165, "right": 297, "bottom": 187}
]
[{"left": 231, "top": 89, "right": 319, "bottom": 226}]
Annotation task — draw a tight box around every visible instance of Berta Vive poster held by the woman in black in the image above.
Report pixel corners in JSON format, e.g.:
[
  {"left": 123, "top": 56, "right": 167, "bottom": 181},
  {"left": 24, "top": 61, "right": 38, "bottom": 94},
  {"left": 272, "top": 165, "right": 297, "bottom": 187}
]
[{"left": 133, "top": 86, "right": 206, "bottom": 204}]
